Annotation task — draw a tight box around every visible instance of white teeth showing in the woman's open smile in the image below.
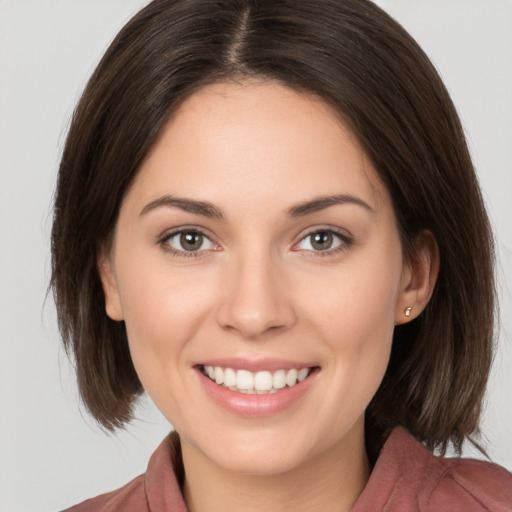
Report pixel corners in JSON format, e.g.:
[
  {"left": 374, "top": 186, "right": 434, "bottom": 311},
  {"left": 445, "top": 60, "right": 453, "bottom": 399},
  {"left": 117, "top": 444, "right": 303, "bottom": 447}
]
[{"left": 201, "top": 366, "right": 316, "bottom": 395}]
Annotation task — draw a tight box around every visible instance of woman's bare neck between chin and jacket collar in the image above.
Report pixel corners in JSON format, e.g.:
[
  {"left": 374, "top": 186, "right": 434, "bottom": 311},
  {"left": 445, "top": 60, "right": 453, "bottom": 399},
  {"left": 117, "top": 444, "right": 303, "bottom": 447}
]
[{"left": 182, "top": 426, "right": 370, "bottom": 512}]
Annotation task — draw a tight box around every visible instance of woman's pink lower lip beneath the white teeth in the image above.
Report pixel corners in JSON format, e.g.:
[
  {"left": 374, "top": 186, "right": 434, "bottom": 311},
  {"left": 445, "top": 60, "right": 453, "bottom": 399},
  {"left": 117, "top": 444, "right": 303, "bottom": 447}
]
[{"left": 196, "top": 368, "right": 318, "bottom": 418}]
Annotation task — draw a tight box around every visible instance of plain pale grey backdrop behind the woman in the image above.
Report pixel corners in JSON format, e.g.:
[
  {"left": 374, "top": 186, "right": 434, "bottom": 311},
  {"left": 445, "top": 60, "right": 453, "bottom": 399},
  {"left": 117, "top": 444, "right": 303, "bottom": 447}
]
[{"left": 0, "top": 0, "right": 512, "bottom": 512}]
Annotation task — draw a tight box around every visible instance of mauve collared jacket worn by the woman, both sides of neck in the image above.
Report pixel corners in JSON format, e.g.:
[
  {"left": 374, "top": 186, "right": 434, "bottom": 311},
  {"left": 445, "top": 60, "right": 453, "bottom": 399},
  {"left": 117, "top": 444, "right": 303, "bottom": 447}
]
[{"left": 62, "top": 428, "right": 512, "bottom": 512}]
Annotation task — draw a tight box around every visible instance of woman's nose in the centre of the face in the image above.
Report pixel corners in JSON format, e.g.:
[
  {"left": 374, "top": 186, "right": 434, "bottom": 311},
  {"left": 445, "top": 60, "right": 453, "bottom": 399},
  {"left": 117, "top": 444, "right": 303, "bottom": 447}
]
[{"left": 218, "top": 255, "right": 296, "bottom": 340}]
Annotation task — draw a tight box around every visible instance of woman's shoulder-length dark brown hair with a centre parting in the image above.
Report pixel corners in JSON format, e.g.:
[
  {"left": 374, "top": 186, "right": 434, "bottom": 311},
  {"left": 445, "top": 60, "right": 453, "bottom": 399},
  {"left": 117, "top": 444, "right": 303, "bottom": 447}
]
[{"left": 51, "top": 0, "right": 494, "bottom": 456}]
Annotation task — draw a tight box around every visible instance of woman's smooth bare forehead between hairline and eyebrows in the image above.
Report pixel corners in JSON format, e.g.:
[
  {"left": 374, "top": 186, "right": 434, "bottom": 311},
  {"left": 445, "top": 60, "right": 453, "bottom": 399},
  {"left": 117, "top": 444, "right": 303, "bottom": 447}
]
[{"left": 128, "top": 82, "right": 388, "bottom": 214}]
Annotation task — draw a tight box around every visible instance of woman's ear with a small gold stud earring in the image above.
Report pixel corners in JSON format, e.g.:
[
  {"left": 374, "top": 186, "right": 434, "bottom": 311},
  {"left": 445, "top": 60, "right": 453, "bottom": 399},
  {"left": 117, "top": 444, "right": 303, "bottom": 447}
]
[{"left": 395, "top": 230, "right": 439, "bottom": 325}]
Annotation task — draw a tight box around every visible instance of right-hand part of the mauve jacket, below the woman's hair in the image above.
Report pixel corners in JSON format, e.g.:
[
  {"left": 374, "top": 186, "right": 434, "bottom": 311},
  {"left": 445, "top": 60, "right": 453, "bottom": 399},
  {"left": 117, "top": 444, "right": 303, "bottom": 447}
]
[{"left": 352, "top": 427, "right": 512, "bottom": 512}]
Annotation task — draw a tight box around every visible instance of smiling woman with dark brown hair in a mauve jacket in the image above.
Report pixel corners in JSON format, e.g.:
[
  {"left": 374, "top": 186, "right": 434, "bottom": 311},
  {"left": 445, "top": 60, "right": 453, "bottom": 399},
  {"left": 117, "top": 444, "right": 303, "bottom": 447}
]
[{"left": 52, "top": 0, "right": 512, "bottom": 511}]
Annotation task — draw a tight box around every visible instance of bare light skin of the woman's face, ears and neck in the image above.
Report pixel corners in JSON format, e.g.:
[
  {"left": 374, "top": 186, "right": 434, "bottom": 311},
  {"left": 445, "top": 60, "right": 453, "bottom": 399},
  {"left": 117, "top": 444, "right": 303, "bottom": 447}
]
[{"left": 99, "top": 82, "right": 437, "bottom": 512}]
